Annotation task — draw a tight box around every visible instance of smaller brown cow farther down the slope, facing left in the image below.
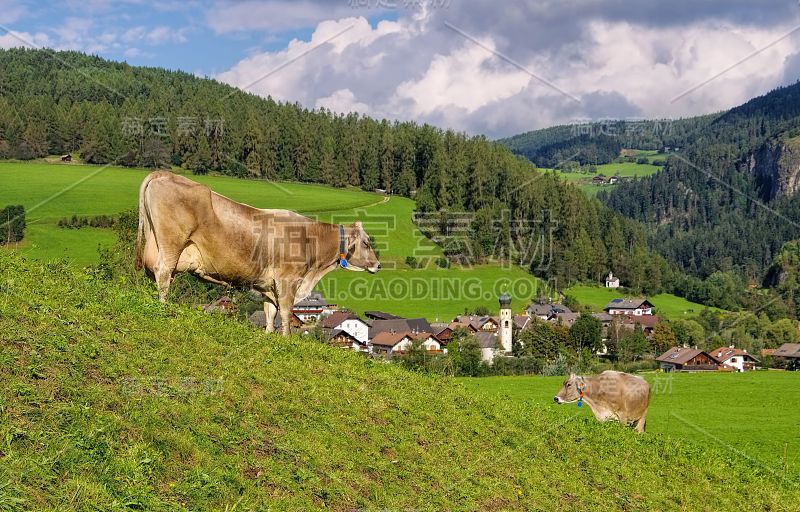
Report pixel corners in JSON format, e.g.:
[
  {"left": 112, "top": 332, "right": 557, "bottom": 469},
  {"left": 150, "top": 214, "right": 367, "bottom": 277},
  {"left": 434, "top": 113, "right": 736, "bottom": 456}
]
[{"left": 554, "top": 370, "right": 650, "bottom": 432}]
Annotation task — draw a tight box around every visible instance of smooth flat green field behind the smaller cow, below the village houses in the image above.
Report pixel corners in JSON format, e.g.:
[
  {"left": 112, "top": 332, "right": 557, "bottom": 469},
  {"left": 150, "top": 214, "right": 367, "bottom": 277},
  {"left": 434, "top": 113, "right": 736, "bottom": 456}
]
[{"left": 459, "top": 371, "right": 800, "bottom": 481}]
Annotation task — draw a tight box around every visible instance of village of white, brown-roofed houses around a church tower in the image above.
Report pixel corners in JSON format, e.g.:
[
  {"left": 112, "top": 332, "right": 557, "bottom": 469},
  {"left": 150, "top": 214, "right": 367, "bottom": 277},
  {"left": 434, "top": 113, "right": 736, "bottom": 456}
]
[{"left": 203, "top": 272, "right": 800, "bottom": 372}]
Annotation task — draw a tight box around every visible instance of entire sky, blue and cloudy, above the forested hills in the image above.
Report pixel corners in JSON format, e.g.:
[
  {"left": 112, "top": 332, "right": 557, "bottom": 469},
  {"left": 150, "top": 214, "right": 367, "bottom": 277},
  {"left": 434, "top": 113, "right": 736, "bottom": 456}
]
[{"left": 0, "top": 0, "right": 800, "bottom": 137}]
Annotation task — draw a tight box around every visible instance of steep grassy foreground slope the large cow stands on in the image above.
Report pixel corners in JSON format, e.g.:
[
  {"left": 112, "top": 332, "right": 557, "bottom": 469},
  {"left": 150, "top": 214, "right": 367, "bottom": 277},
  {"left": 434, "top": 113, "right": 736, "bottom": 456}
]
[{"left": 0, "top": 254, "right": 800, "bottom": 510}]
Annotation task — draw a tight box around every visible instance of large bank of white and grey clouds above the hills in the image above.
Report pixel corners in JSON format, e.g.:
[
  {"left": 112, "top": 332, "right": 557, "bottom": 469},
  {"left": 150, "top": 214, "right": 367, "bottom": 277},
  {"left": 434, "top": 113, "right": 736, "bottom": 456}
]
[{"left": 212, "top": 1, "right": 800, "bottom": 136}]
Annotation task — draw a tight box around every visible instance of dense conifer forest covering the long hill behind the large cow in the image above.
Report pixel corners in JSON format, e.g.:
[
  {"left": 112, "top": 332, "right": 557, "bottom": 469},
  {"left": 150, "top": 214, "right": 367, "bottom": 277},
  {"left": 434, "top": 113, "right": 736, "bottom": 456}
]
[{"left": 0, "top": 49, "right": 684, "bottom": 292}]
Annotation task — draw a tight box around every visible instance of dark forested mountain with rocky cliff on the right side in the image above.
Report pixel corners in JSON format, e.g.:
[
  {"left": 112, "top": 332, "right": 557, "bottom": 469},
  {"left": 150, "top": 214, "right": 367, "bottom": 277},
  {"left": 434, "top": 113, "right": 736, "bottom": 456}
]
[{"left": 500, "top": 84, "right": 800, "bottom": 281}]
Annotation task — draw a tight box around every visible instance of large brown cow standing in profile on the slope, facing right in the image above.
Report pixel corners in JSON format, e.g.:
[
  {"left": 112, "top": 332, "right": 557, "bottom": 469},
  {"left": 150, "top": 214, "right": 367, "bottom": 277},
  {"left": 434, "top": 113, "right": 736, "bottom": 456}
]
[{"left": 136, "top": 171, "right": 381, "bottom": 334}]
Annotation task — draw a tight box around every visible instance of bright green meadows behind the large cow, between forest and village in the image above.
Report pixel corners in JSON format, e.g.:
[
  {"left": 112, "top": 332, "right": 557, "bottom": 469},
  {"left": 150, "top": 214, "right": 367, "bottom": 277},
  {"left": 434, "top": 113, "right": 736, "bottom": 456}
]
[{"left": 0, "top": 162, "right": 712, "bottom": 321}]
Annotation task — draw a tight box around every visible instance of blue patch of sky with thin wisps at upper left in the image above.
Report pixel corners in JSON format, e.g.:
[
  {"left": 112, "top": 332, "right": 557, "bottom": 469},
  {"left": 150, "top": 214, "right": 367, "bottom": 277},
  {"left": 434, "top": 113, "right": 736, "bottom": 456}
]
[{"left": 0, "top": 0, "right": 388, "bottom": 75}]
